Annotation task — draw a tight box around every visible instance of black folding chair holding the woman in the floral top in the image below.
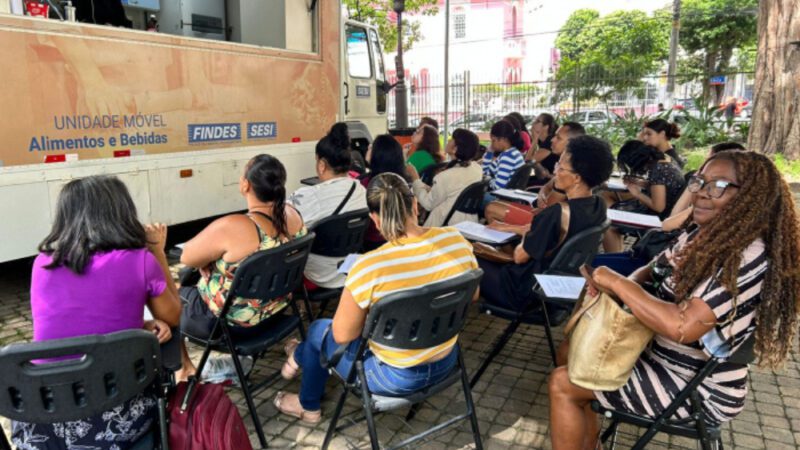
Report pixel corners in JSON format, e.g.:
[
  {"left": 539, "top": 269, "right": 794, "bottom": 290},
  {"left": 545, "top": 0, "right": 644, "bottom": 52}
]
[{"left": 181, "top": 233, "right": 314, "bottom": 448}]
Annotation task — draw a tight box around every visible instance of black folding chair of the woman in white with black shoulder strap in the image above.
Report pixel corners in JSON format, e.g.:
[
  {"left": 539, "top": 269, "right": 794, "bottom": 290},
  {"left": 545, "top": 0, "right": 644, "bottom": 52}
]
[{"left": 303, "top": 208, "right": 370, "bottom": 318}]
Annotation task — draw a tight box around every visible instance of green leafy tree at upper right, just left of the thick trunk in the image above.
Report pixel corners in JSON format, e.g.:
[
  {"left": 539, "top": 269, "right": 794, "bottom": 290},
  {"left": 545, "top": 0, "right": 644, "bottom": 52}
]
[{"left": 680, "top": 0, "right": 758, "bottom": 104}]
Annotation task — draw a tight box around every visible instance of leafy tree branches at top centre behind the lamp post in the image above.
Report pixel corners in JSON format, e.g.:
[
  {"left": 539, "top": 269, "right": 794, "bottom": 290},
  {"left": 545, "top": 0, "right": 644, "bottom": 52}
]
[{"left": 342, "top": 0, "right": 439, "bottom": 52}]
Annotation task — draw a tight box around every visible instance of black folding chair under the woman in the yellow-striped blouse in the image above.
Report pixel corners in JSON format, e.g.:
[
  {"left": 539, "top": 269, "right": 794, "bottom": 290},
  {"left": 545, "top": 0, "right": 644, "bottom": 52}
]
[{"left": 322, "top": 270, "right": 483, "bottom": 450}]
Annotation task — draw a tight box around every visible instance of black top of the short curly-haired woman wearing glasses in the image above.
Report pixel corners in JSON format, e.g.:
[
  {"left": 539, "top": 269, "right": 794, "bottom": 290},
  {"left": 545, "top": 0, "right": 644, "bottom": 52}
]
[{"left": 504, "top": 195, "right": 606, "bottom": 299}]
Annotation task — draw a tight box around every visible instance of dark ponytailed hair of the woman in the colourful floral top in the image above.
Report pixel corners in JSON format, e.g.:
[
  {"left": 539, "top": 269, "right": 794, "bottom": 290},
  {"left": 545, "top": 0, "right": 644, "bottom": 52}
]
[{"left": 244, "top": 154, "right": 289, "bottom": 237}]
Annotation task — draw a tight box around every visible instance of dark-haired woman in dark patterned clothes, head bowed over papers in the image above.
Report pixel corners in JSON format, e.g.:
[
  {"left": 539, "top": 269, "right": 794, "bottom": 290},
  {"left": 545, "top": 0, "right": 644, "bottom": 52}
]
[{"left": 603, "top": 140, "right": 686, "bottom": 253}]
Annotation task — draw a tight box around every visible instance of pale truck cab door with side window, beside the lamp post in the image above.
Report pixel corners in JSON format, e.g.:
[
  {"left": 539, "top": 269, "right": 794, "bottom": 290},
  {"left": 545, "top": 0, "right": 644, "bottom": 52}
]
[{"left": 342, "top": 21, "right": 386, "bottom": 137}]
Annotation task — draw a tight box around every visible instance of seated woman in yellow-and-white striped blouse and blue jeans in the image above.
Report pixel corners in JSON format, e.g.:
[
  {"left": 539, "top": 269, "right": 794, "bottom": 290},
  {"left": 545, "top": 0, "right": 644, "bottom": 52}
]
[{"left": 274, "top": 173, "right": 478, "bottom": 423}]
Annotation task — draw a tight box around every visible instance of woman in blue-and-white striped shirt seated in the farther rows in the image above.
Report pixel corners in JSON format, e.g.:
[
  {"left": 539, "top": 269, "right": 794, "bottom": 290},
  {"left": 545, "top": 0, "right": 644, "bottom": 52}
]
[{"left": 483, "top": 120, "right": 525, "bottom": 190}]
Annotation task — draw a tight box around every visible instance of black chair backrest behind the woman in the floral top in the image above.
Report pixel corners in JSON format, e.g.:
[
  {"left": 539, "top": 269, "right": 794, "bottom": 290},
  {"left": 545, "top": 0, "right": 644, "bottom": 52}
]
[{"left": 227, "top": 232, "right": 315, "bottom": 310}]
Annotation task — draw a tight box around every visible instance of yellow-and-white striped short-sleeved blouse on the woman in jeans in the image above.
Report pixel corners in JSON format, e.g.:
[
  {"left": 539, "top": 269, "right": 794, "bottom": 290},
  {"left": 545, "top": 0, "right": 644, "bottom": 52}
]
[{"left": 345, "top": 227, "right": 478, "bottom": 368}]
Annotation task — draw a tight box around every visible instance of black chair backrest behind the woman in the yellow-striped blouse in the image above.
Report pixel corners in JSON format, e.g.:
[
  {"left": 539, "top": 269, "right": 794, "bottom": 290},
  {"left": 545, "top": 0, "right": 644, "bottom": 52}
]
[{"left": 362, "top": 269, "right": 483, "bottom": 350}]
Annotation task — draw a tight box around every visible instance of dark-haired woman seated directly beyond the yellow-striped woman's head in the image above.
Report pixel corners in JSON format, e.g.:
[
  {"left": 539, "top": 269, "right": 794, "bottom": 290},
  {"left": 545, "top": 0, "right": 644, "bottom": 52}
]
[{"left": 360, "top": 134, "right": 412, "bottom": 252}]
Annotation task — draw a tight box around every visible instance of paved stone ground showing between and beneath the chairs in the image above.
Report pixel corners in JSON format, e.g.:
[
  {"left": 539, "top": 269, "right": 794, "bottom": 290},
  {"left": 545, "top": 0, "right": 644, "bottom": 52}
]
[{"left": 0, "top": 263, "right": 800, "bottom": 450}]
